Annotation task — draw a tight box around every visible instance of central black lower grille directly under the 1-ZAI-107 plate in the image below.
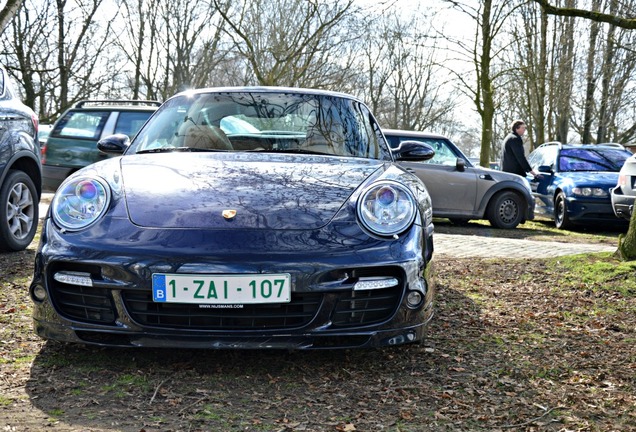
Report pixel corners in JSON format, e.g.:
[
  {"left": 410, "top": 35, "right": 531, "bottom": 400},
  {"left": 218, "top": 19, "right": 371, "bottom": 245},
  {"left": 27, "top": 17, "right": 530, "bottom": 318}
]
[{"left": 122, "top": 290, "right": 323, "bottom": 330}]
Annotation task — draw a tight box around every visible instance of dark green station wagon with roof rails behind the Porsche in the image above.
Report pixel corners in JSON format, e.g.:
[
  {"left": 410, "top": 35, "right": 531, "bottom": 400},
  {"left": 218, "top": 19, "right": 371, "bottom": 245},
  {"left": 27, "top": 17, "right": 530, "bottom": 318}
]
[{"left": 42, "top": 100, "right": 161, "bottom": 191}]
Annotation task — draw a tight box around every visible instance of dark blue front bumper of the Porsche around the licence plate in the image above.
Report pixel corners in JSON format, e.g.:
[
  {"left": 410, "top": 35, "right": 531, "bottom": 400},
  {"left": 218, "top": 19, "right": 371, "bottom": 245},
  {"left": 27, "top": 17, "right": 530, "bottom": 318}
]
[{"left": 30, "top": 220, "right": 434, "bottom": 349}]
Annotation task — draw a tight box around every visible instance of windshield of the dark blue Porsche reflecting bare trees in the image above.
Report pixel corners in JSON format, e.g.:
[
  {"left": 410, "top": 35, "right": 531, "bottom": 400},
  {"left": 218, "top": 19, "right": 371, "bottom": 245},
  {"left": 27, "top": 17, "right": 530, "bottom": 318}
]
[{"left": 136, "top": 92, "right": 390, "bottom": 159}]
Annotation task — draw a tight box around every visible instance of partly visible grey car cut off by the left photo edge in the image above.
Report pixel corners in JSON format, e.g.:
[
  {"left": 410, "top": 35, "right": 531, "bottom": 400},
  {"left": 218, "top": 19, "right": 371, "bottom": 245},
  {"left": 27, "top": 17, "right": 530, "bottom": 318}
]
[{"left": 0, "top": 67, "right": 42, "bottom": 251}]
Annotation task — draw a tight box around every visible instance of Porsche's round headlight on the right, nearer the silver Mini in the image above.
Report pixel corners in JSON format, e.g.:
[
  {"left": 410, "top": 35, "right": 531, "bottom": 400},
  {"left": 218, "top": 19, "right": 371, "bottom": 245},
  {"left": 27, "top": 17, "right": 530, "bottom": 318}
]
[{"left": 358, "top": 181, "right": 417, "bottom": 236}]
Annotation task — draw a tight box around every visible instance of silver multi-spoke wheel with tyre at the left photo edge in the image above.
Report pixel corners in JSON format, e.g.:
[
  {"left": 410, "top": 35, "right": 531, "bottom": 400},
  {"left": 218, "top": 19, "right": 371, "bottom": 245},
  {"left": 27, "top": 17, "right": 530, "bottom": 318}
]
[{"left": 0, "top": 171, "right": 38, "bottom": 251}]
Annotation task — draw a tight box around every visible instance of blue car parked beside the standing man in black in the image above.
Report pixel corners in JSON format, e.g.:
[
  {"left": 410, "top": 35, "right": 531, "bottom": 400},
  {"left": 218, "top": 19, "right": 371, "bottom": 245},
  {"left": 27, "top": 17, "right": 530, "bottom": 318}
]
[{"left": 528, "top": 142, "right": 631, "bottom": 229}]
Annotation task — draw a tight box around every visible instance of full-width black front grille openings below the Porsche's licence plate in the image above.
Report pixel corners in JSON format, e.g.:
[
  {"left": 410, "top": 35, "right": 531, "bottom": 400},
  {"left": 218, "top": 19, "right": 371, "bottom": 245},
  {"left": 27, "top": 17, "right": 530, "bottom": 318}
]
[{"left": 49, "top": 264, "right": 404, "bottom": 331}]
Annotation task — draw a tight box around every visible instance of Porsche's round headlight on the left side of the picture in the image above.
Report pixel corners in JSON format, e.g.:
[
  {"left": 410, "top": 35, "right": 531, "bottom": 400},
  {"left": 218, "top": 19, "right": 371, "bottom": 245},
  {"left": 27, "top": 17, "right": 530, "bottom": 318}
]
[{"left": 51, "top": 177, "right": 110, "bottom": 231}]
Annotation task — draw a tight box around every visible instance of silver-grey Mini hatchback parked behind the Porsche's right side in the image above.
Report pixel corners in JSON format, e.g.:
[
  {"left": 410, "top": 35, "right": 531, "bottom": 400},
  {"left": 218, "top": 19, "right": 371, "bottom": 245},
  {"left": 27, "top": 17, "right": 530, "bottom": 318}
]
[{"left": 383, "top": 129, "right": 534, "bottom": 228}]
